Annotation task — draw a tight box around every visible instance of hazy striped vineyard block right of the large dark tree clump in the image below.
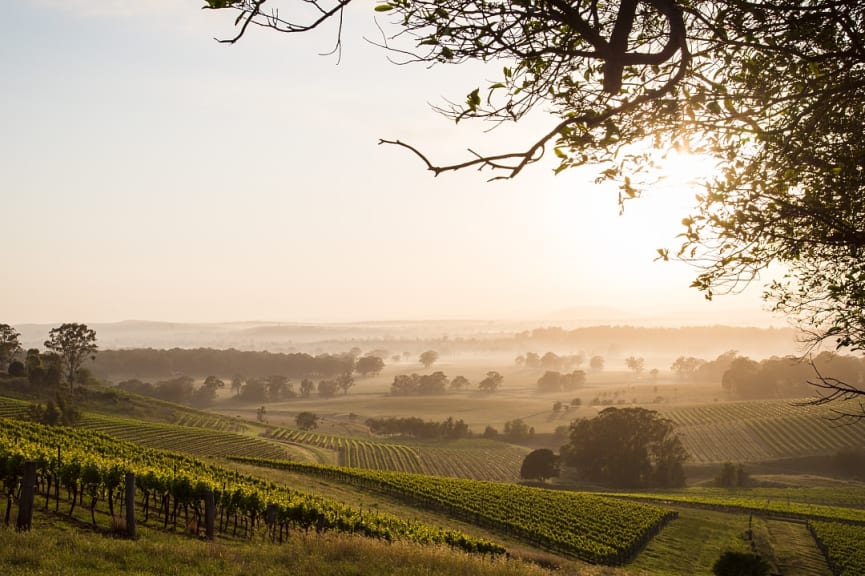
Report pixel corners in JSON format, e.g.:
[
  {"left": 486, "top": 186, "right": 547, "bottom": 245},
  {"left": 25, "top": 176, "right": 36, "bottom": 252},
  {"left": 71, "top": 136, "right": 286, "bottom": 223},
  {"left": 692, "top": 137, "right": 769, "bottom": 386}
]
[{"left": 663, "top": 400, "right": 865, "bottom": 464}]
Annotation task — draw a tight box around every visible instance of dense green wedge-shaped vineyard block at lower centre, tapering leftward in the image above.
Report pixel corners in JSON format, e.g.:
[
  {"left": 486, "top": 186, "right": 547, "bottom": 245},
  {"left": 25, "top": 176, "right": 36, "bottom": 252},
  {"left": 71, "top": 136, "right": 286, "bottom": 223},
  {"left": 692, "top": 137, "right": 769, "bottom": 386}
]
[{"left": 235, "top": 458, "right": 676, "bottom": 565}]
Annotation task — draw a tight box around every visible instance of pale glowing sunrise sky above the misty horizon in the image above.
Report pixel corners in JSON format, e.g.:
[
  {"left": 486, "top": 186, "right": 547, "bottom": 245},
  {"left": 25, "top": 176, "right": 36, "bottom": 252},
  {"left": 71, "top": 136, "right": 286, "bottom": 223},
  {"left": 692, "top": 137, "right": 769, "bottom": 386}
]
[{"left": 0, "top": 0, "right": 783, "bottom": 325}]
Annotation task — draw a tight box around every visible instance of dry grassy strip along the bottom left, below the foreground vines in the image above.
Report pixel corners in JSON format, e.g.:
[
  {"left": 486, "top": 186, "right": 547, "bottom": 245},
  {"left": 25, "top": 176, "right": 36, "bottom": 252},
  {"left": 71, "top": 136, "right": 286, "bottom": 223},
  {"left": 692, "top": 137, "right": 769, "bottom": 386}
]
[{"left": 0, "top": 514, "right": 580, "bottom": 576}]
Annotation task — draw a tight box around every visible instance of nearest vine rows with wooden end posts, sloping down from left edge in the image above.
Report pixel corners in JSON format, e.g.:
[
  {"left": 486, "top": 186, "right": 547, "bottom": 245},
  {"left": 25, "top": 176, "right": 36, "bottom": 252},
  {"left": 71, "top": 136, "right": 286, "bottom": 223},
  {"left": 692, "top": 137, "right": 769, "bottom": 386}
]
[{"left": 0, "top": 419, "right": 504, "bottom": 554}]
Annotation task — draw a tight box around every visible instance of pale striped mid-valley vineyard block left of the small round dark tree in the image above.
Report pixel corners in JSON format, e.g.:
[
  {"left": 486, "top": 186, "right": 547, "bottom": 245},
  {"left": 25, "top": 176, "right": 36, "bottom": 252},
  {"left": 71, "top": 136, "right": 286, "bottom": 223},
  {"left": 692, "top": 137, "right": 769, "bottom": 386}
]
[{"left": 266, "top": 428, "right": 528, "bottom": 482}]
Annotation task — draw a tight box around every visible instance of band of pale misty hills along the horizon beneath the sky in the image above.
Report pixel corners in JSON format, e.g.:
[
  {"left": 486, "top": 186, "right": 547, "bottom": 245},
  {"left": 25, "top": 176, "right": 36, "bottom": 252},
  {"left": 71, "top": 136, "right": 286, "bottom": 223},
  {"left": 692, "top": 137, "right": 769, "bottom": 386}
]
[{"left": 15, "top": 320, "right": 797, "bottom": 356}]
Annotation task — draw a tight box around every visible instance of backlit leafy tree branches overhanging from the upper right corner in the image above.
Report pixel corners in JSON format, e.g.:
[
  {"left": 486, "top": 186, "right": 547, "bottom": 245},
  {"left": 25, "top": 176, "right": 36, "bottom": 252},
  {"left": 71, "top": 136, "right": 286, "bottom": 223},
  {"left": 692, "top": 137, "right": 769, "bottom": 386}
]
[{"left": 206, "top": 0, "right": 865, "bottom": 404}]
